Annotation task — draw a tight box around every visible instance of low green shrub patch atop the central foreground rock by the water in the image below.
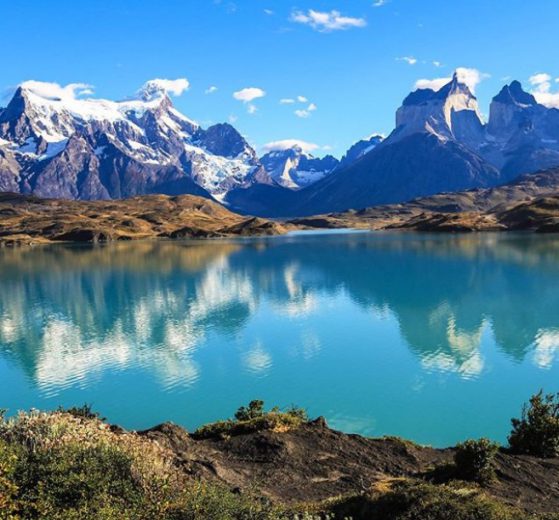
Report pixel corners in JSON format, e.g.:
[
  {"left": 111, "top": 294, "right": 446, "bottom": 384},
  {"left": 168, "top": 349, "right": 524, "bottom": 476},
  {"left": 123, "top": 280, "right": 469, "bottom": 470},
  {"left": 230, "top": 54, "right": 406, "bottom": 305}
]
[{"left": 192, "top": 401, "right": 308, "bottom": 439}]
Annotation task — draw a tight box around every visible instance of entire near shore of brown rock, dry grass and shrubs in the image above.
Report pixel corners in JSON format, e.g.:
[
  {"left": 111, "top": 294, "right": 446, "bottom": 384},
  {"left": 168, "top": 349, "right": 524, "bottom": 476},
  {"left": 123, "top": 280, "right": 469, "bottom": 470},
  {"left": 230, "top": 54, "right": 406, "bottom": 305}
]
[{"left": 0, "top": 402, "right": 559, "bottom": 520}]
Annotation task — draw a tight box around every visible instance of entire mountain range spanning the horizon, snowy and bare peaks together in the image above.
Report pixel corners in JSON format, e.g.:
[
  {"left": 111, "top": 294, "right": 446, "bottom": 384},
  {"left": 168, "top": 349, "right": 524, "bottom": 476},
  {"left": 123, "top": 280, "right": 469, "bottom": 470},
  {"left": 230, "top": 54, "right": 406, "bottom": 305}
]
[{"left": 0, "top": 71, "right": 559, "bottom": 217}]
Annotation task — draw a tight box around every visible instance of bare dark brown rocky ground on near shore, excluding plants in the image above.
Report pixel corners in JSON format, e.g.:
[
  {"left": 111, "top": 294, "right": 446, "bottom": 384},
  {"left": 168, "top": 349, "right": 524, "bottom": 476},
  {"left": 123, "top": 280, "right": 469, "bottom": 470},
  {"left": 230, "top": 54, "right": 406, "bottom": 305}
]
[{"left": 140, "top": 418, "right": 559, "bottom": 513}]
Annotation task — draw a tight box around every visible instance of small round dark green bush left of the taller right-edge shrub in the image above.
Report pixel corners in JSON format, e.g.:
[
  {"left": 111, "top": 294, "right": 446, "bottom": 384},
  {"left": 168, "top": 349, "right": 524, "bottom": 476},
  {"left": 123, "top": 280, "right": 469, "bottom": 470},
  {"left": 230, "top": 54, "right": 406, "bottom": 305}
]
[{"left": 454, "top": 439, "right": 499, "bottom": 483}]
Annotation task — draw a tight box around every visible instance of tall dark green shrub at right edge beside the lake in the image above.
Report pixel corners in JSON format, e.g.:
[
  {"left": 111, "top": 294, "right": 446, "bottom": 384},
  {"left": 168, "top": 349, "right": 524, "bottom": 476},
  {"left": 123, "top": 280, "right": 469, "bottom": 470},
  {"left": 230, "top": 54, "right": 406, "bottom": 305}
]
[{"left": 509, "top": 390, "right": 559, "bottom": 458}]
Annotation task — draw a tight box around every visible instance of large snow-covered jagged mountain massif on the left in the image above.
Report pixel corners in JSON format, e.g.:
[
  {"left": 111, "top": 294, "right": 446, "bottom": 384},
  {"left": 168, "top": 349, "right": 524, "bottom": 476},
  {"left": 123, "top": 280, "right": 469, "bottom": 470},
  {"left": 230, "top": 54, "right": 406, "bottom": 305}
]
[{"left": 0, "top": 80, "right": 272, "bottom": 199}]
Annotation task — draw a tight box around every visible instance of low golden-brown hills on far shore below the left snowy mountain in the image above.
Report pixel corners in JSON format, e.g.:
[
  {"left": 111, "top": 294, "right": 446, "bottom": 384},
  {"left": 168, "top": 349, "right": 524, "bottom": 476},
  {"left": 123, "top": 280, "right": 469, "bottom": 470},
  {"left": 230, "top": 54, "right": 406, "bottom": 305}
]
[{"left": 0, "top": 193, "right": 286, "bottom": 245}]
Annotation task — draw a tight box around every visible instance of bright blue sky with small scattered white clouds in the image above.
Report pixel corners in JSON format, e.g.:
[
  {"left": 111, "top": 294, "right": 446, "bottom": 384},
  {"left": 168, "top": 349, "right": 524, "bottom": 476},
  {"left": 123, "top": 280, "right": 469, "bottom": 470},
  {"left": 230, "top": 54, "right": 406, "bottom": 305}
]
[{"left": 0, "top": 0, "right": 559, "bottom": 156}]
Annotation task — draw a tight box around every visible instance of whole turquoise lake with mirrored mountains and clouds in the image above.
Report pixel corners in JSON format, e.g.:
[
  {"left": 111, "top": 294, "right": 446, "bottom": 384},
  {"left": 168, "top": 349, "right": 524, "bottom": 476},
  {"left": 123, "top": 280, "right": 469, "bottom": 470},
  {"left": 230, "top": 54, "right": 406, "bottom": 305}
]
[{"left": 0, "top": 233, "right": 559, "bottom": 446}]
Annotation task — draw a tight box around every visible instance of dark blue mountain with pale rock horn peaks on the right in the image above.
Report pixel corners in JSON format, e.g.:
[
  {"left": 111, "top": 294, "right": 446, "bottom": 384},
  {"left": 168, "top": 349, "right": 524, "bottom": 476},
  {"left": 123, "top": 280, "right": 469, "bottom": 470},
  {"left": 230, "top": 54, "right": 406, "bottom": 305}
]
[{"left": 274, "top": 73, "right": 559, "bottom": 216}]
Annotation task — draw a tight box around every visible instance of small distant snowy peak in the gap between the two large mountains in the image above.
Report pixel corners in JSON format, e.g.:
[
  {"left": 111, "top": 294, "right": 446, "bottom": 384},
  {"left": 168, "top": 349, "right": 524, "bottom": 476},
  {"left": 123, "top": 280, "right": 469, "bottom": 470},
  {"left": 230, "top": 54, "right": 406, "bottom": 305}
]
[{"left": 260, "top": 145, "right": 339, "bottom": 189}]
